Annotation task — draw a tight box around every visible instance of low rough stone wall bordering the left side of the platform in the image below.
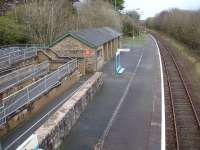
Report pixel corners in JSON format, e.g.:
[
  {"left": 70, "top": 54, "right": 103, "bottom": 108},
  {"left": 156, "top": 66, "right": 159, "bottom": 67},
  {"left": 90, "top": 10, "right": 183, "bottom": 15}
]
[{"left": 35, "top": 72, "right": 103, "bottom": 150}]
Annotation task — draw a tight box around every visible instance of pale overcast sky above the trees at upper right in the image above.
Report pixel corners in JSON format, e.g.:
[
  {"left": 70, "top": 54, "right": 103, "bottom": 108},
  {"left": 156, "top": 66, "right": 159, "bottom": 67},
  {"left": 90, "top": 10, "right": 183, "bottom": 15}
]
[{"left": 125, "top": 0, "right": 200, "bottom": 19}]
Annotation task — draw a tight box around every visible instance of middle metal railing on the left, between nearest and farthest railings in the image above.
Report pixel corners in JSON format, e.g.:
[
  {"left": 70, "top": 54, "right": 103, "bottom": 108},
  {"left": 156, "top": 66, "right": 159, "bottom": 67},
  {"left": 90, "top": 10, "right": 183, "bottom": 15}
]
[{"left": 0, "top": 61, "right": 49, "bottom": 93}]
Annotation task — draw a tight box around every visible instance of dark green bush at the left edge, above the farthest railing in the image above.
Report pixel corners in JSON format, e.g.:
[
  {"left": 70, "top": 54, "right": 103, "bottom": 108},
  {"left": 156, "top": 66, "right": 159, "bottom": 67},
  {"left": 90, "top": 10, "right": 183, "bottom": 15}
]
[{"left": 0, "top": 16, "right": 28, "bottom": 45}]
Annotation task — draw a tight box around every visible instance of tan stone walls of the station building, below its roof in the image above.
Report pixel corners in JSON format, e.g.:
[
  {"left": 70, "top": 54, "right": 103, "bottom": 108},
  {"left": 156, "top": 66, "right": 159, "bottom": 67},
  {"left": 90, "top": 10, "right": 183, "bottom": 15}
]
[{"left": 51, "top": 36, "right": 120, "bottom": 73}]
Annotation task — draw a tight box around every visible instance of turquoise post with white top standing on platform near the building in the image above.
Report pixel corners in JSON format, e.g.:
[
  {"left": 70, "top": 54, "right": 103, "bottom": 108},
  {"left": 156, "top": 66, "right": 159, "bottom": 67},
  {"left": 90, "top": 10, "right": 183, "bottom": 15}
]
[{"left": 115, "top": 49, "right": 130, "bottom": 75}]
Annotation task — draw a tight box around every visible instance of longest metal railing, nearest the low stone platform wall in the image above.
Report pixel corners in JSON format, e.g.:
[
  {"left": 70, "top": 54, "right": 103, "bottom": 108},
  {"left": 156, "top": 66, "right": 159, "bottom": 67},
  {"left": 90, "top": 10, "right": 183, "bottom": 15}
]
[{"left": 0, "top": 59, "right": 77, "bottom": 125}]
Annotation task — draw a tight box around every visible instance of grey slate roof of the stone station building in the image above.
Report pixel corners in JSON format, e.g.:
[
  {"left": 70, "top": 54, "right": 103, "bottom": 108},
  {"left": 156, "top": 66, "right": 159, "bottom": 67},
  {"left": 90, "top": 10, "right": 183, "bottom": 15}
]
[{"left": 51, "top": 27, "right": 122, "bottom": 48}]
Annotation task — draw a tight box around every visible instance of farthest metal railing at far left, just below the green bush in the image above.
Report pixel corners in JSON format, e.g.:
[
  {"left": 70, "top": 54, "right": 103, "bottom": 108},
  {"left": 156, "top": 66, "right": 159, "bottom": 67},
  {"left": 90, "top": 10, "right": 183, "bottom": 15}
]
[{"left": 0, "top": 47, "right": 38, "bottom": 70}]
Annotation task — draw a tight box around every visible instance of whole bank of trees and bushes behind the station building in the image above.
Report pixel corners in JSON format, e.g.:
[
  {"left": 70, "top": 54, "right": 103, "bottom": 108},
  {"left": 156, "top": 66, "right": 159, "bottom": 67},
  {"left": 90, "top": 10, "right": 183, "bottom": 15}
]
[{"left": 0, "top": 0, "right": 140, "bottom": 45}]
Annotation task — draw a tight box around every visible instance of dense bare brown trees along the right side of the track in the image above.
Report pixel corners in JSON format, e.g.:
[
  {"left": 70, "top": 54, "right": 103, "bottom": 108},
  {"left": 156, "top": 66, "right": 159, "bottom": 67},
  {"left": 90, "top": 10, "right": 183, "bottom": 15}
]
[{"left": 146, "top": 9, "right": 200, "bottom": 49}]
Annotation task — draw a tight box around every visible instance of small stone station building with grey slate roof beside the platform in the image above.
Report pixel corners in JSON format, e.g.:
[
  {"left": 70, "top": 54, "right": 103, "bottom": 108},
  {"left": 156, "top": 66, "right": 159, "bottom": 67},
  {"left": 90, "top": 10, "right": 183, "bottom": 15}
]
[{"left": 50, "top": 27, "right": 122, "bottom": 73}]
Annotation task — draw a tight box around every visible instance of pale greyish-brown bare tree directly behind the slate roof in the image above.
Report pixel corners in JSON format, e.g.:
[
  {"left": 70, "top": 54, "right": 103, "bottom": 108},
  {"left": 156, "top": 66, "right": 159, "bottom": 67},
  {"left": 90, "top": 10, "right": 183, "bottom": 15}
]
[{"left": 79, "top": 0, "right": 122, "bottom": 30}]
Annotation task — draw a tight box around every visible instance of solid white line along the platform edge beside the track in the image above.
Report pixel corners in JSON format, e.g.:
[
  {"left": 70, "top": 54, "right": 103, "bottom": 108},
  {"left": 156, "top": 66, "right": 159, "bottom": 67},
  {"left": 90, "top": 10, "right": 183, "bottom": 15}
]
[{"left": 150, "top": 35, "right": 166, "bottom": 150}]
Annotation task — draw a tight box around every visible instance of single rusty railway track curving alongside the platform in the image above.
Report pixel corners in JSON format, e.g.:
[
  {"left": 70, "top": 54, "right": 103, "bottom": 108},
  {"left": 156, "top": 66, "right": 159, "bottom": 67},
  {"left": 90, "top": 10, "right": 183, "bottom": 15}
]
[{"left": 158, "top": 41, "right": 200, "bottom": 150}]
